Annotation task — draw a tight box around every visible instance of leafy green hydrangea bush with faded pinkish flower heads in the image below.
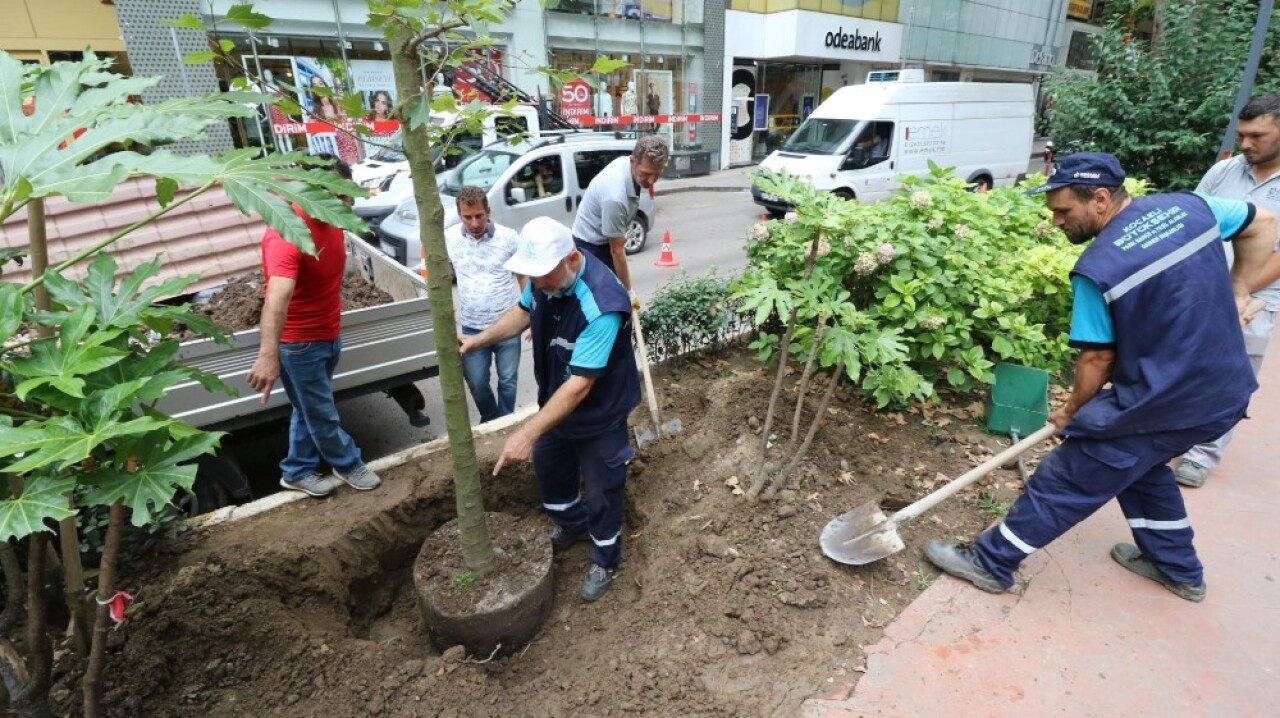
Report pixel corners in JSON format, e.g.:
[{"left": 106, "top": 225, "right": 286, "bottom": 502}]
[{"left": 735, "top": 165, "right": 1080, "bottom": 407}]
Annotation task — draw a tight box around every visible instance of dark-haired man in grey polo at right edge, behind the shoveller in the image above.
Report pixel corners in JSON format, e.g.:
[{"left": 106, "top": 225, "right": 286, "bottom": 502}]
[{"left": 1174, "top": 95, "right": 1280, "bottom": 488}]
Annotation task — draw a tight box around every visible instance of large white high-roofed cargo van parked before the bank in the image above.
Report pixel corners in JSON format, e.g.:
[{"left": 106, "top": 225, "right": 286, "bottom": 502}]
[{"left": 751, "top": 76, "right": 1036, "bottom": 216}]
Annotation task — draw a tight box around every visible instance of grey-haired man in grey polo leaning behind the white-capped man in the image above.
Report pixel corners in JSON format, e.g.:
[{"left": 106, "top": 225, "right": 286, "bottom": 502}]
[{"left": 573, "top": 134, "right": 669, "bottom": 291}]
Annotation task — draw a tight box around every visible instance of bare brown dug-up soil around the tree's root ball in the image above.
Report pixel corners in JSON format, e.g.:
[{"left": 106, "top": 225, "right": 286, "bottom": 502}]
[{"left": 56, "top": 351, "right": 1047, "bottom": 718}]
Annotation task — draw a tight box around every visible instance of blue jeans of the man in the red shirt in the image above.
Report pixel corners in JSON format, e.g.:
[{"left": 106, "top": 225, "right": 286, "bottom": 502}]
[{"left": 280, "top": 339, "right": 364, "bottom": 481}]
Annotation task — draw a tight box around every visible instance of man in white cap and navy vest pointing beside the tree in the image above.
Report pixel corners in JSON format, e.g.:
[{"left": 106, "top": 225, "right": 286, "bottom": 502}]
[{"left": 460, "top": 218, "right": 640, "bottom": 602}]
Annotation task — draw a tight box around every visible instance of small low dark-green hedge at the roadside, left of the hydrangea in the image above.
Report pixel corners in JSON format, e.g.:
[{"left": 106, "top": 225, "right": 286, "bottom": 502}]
[{"left": 640, "top": 273, "right": 750, "bottom": 362}]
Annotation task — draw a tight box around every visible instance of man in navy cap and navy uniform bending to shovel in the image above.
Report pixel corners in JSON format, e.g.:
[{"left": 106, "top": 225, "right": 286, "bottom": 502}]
[{"left": 925, "top": 152, "right": 1276, "bottom": 602}]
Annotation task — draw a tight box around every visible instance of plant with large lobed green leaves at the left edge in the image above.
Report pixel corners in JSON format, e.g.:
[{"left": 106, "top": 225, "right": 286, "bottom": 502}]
[{"left": 0, "top": 52, "right": 364, "bottom": 715}]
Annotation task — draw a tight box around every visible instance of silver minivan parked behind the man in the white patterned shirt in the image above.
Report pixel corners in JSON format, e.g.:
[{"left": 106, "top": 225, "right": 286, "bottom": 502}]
[{"left": 376, "top": 132, "right": 658, "bottom": 265}]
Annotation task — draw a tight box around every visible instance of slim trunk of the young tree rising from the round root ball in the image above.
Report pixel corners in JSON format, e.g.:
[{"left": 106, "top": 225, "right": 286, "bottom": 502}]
[{"left": 390, "top": 27, "right": 493, "bottom": 575}]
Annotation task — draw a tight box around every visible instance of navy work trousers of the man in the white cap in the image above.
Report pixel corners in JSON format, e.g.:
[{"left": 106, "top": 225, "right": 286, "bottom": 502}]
[{"left": 534, "top": 420, "right": 635, "bottom": 568}]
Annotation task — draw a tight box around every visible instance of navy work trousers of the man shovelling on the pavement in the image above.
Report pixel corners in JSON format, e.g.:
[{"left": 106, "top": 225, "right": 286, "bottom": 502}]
[{"left": 974, "top": 412, "right": 1243, "bottom": 586}]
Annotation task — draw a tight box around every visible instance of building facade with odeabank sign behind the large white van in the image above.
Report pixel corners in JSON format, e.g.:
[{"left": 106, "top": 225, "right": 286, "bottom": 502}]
[{"left": 721, "top": 0, "right": 1076, "bottom": 166}]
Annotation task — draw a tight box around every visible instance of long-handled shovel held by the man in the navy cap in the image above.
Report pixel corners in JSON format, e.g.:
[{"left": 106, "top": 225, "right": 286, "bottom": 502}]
[{"left": 818, "top": 424, "right": 1057, "bottom": 566}]
